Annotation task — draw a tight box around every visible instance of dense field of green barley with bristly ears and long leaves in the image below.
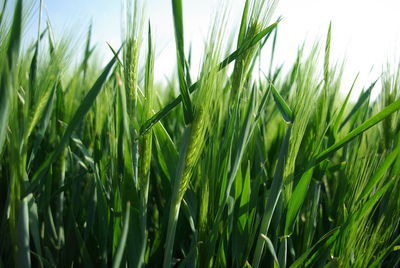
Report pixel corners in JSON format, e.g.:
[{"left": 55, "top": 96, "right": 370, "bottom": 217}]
[{"left": 0, "top": 0, "right": 400, "bottom": 268}]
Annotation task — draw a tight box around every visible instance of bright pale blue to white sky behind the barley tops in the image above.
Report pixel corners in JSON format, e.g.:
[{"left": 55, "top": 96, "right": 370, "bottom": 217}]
[{"left": 20, "top": 0, "right": 400, "bottom": 97}]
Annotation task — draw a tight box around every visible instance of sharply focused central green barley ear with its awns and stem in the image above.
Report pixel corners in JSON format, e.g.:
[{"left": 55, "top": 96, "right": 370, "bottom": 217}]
[{"left": 163, "top": 7, "right": 225, "bottom": 268}]
